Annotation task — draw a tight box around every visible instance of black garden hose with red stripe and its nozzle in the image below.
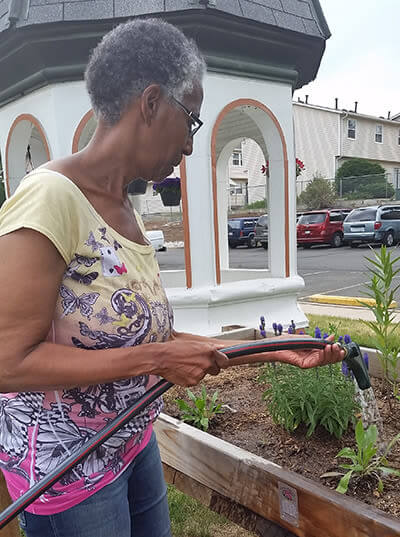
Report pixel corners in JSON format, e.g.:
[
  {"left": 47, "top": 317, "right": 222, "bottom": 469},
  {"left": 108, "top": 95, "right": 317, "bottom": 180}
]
[{"left": 0, "top": 337, "right": 370, "bottom": 529}]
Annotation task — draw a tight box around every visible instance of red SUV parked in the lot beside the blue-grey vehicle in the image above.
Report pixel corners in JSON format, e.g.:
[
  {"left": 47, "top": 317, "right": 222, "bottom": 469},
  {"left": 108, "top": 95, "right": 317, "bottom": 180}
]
[{"left": 297, "top": 209, "right": 348, "bottom": 248}]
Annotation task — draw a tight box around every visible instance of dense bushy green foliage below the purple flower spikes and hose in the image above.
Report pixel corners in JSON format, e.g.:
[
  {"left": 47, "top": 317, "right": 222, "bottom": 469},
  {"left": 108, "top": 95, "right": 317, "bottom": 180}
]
[{"left": 259, "top": 364, "right": 358, "bottom": 438}]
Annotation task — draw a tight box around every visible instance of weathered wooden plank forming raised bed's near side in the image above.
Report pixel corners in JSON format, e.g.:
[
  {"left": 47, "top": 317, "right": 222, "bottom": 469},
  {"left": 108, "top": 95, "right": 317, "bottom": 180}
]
[{"left": 155, "top": 414, "right": 400, "bottom": 537}]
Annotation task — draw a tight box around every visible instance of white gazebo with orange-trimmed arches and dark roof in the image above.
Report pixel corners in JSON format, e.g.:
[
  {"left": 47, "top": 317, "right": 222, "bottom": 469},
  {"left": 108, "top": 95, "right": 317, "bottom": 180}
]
[{"left": 0, "top": 0, "right": 330, "bottom": 334}]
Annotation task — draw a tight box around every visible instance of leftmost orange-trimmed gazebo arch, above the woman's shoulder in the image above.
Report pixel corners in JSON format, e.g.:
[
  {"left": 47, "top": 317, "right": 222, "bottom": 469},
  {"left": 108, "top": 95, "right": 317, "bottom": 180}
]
[{"left": 5, "top": 114, "right": 51, "bottom": 196}]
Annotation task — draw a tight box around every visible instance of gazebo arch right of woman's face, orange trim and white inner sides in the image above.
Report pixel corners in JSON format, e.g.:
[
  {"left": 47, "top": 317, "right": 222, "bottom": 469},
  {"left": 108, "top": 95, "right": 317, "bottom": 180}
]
[{"left": 211, "top": 99, "right": 290, "bottom": 283}]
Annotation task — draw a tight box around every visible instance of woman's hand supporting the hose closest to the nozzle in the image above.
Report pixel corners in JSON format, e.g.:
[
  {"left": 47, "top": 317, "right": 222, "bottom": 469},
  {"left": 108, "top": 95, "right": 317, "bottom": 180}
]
[{"left": 277, "top": 336, "right": 345, "bottom": 369}]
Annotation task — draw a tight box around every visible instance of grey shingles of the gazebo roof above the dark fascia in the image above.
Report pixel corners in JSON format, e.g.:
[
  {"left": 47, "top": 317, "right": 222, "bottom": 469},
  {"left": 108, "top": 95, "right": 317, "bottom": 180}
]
[{"left": 0, "top": 0, "right": 330, "bottom": 39}]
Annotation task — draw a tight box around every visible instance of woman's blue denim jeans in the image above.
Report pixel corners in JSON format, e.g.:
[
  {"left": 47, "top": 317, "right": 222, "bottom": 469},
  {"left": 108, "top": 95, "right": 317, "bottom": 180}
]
[{"left": 20, "top": 432, "right": 171, "bottom": 537}]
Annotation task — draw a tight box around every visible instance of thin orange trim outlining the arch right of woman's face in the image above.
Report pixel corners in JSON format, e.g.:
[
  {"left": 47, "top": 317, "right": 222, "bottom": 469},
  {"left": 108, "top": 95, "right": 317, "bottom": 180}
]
[{"left": 211, "top": 99, "right": 290, "bottom": 284}]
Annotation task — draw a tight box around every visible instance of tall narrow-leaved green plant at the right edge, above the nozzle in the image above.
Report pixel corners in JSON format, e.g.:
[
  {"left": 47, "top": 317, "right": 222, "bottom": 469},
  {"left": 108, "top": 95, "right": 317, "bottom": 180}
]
[{"left": 362, "top": 246, "right": 400, "bottom": 404}]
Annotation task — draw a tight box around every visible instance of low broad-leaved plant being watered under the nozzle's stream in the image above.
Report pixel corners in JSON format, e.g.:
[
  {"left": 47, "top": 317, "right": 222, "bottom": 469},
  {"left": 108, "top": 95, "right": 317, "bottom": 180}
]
[{"left": 332, "top": 420, "right": 400, "bottom": 494}]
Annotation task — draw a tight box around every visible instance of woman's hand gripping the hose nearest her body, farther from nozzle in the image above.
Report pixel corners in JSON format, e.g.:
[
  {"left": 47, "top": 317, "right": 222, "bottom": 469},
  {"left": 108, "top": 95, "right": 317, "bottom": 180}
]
[{"left": 154, "top": 339, "right": 229, "bottom": 387}]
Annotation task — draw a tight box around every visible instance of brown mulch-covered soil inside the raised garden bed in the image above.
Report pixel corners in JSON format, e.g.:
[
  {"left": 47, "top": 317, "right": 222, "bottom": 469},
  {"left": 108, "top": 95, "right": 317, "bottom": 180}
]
[{"left": 164, "top": 366, "right": 400, "bottom": 517}]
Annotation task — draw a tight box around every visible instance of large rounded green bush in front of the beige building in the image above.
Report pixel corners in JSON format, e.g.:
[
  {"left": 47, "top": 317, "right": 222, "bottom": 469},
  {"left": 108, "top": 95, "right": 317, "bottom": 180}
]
[{"left": 335, "top": 158, "right": 394, "bottom": 199}]
